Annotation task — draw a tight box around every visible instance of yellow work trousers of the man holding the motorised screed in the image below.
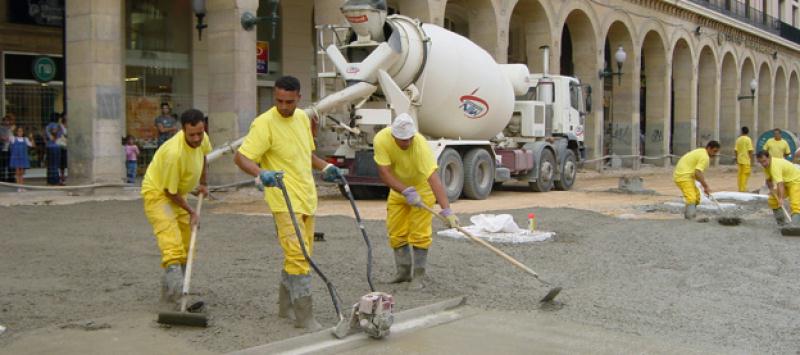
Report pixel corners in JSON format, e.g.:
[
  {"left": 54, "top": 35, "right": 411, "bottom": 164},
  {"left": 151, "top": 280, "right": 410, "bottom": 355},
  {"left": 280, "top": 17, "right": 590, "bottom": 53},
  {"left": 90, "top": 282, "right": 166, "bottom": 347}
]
[{"left": 272, "top": 212, "right": 314, "bottom": 275}]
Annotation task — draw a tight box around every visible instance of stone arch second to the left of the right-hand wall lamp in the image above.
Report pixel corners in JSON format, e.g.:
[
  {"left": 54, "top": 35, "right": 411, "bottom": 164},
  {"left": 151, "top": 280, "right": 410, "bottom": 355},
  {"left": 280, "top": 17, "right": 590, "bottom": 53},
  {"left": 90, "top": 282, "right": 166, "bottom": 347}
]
[{"left": 695, "top": 46, "right": 719, "bottom": 147}]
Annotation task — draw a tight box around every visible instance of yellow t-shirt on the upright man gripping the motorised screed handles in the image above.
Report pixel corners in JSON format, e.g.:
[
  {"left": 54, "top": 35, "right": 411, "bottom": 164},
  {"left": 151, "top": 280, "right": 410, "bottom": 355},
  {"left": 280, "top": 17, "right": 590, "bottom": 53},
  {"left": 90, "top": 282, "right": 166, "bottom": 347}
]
[{"left": 239, "top": 107, "right": 317, "bottom": 215}]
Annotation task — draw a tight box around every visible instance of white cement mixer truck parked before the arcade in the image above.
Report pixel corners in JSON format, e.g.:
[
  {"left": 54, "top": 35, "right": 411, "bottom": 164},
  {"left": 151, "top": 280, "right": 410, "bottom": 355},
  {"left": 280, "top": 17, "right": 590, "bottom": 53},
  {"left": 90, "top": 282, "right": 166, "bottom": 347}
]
[{"left": 306, "top": 0, "right": 591, "bottom": 201}]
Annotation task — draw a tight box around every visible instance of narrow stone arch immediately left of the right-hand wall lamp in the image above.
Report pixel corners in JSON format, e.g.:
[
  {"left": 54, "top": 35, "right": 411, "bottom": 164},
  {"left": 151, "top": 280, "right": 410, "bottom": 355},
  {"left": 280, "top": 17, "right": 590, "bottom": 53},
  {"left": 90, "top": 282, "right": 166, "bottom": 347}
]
[{"left": 719, "top": 53, "right": 736, "bottom": 164}]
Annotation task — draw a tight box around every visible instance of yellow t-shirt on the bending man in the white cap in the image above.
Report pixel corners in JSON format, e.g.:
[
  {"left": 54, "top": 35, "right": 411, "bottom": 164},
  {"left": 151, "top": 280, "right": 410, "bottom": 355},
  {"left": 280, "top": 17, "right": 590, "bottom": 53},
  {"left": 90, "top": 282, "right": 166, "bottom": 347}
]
[{"left": 372, "top": 127, "right": 439, "bottom": 186}]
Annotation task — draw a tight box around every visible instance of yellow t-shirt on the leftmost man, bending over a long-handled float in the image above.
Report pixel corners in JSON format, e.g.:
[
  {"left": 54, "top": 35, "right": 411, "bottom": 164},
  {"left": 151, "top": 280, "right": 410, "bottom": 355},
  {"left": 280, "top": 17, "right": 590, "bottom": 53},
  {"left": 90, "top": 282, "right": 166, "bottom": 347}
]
[{"left": 142, "top": 130, "right": 211, "bottom": 196}]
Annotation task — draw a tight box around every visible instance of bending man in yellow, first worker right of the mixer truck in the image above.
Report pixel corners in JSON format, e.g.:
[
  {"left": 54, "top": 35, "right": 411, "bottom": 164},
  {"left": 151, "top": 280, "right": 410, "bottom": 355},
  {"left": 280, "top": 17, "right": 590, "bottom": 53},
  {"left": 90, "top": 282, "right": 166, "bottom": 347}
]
[{"left": 672, "top": 141, "right": 720, "bottom": 220}]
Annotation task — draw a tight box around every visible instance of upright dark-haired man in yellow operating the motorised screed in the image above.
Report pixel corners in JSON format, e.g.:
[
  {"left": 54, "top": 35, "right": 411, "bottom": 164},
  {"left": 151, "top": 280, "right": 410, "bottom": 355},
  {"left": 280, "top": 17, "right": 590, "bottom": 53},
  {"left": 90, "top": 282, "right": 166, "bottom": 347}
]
[{"left": 234, "top": 76, "right": 341, "bottom": 331}]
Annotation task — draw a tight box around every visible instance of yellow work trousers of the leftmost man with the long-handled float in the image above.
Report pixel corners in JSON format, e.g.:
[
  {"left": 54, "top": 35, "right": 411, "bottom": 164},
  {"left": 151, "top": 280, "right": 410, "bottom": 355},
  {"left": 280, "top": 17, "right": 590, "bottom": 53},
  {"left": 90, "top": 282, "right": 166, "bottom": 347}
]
[{"left": 144, "top": 193, "right": 192, "bottom": 268}]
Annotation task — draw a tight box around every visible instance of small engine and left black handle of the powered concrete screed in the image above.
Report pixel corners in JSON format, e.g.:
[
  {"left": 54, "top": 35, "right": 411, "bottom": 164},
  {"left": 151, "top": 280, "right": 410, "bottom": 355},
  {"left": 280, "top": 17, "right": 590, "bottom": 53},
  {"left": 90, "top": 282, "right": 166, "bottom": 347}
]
[{"left": 276, "top": 172, "right": 394, "bottom": 339}]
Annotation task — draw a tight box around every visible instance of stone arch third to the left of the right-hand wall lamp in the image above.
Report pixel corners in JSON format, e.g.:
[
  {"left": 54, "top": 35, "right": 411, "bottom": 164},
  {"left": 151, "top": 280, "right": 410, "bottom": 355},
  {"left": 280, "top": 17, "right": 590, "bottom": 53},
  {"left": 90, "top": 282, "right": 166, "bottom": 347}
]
[{"left": 670, "top": 39, "right": 695, "bottom": 156}]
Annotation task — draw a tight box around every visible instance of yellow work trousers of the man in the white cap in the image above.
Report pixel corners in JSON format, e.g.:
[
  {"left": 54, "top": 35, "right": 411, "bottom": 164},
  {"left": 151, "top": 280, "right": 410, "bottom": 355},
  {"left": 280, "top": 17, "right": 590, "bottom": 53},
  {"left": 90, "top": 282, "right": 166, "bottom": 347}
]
[{"left": 386, "top": 183, "right": 436, "bottom": 249}]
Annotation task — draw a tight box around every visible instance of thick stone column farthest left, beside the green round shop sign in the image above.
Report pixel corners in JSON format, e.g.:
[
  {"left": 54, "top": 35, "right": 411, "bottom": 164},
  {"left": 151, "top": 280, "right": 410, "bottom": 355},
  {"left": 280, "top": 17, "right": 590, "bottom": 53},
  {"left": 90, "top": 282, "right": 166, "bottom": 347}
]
[{"left": 66, "top": 0, "right": 125, "bottom": 184}]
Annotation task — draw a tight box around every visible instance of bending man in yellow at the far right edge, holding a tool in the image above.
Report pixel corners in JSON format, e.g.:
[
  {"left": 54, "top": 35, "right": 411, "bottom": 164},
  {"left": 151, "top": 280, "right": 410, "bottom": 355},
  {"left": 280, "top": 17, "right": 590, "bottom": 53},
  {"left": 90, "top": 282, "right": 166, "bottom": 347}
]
[{"left": 756, "top": 150, "right": 800, "bottom": 225}]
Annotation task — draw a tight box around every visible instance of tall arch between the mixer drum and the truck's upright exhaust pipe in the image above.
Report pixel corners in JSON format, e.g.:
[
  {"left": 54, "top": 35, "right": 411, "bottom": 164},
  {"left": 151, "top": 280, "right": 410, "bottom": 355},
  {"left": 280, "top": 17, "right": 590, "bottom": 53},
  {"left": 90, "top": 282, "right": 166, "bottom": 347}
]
[{"left": 508, "top": 0, "right": 553, "bottom": 73}]
